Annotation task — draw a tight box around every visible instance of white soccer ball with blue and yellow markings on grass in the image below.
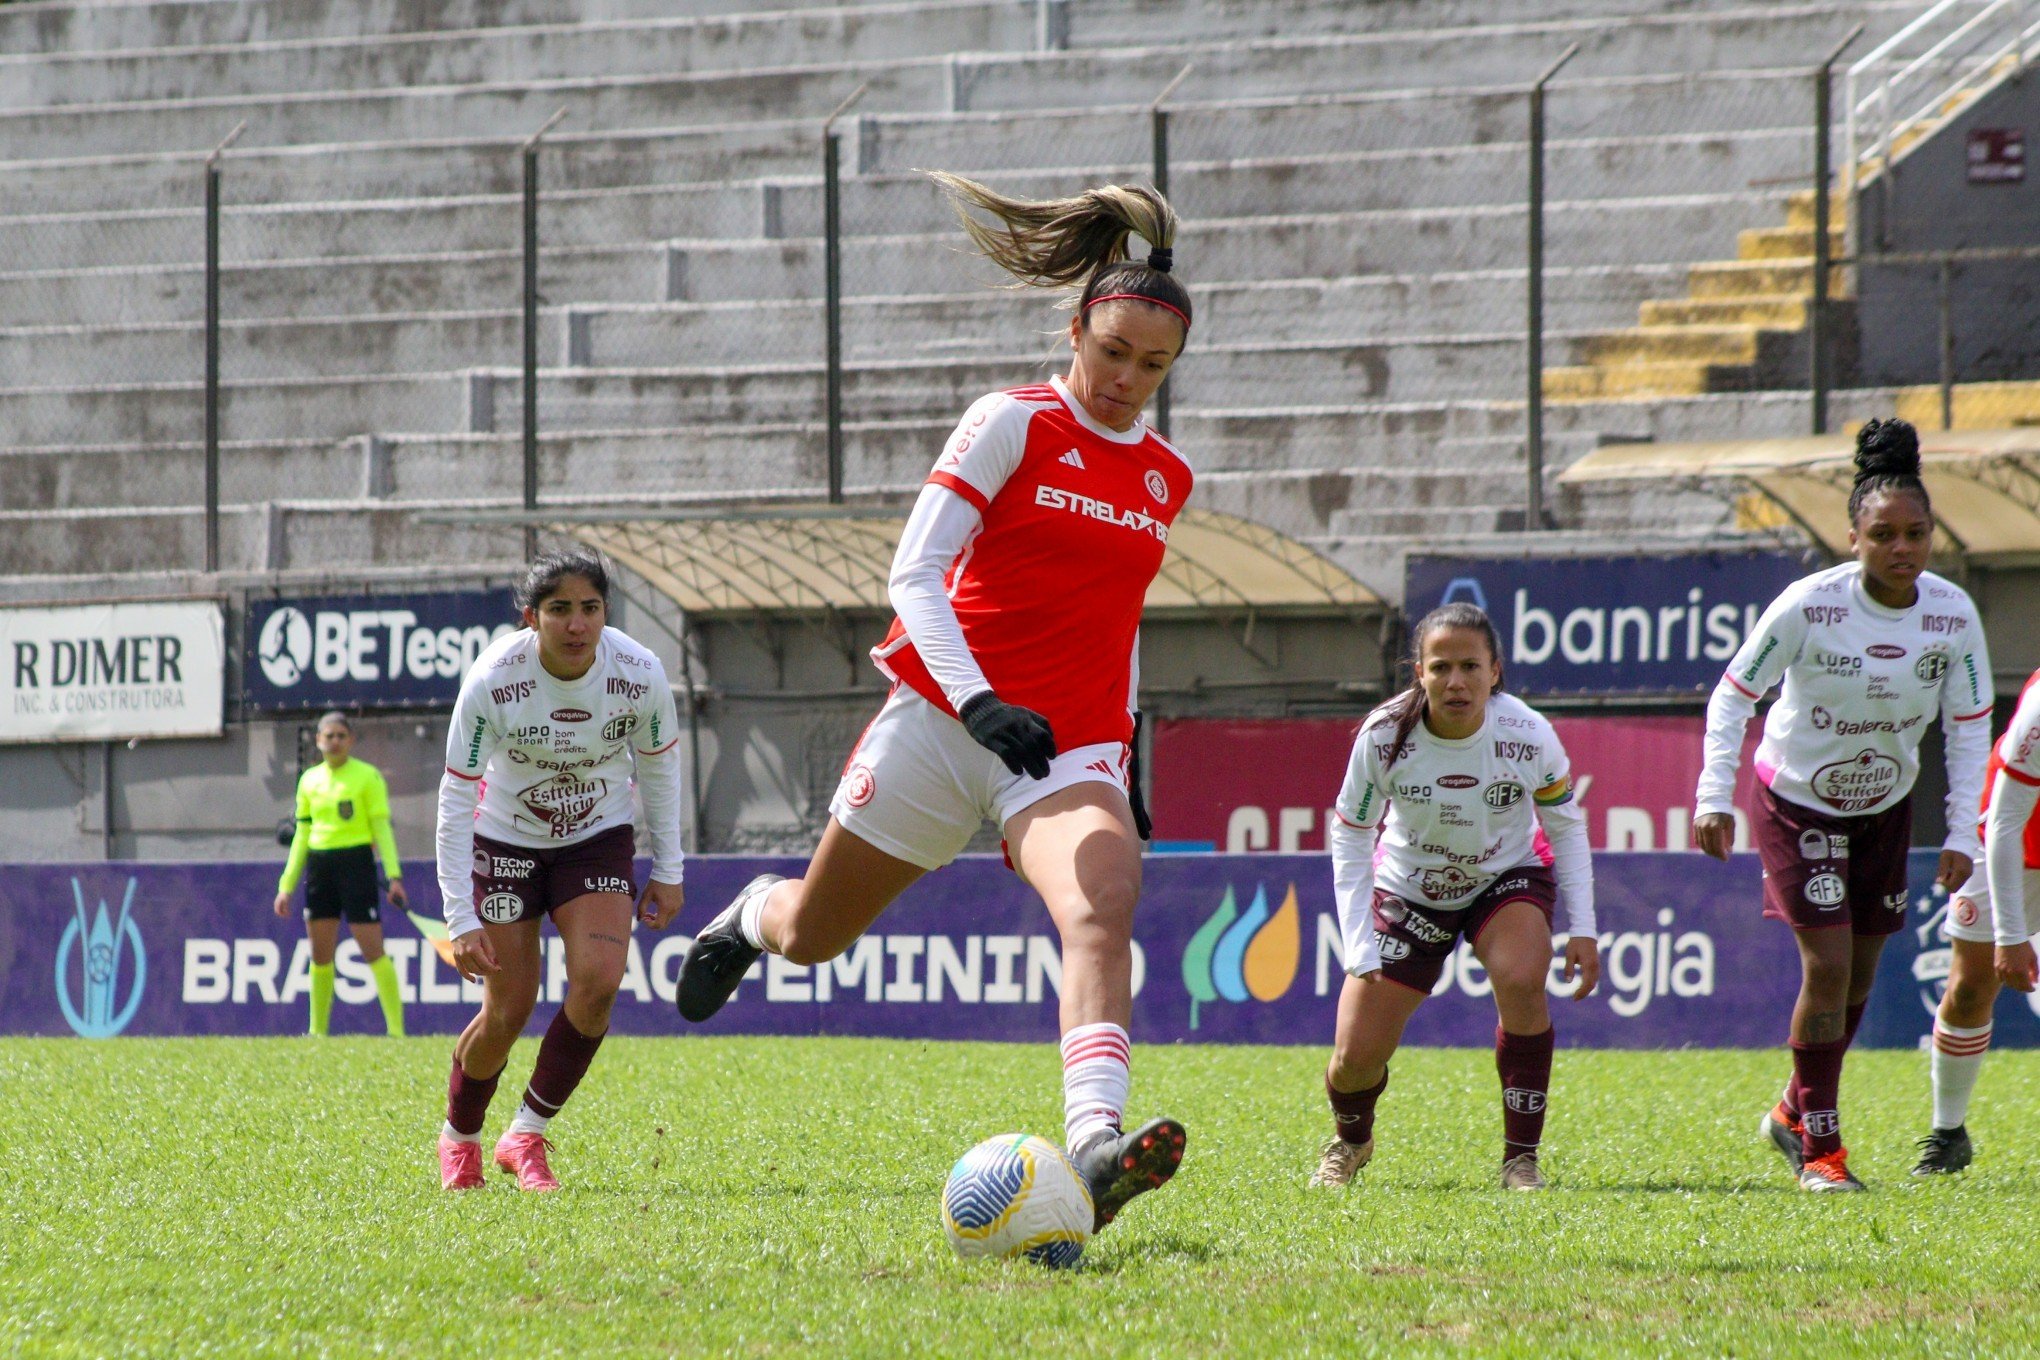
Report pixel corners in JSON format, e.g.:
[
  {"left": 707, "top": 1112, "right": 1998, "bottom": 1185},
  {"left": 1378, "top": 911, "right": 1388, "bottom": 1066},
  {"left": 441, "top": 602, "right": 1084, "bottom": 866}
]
[{"left": 942, "top": 1134, "right": 1091, "bottom": 1268}]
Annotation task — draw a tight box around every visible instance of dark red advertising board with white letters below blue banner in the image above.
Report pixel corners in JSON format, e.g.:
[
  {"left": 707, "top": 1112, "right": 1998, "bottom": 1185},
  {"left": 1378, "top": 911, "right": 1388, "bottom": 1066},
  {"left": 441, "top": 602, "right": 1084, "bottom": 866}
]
[{"left": 1149, "top": 714, "right": 1756, "bottom": 854}]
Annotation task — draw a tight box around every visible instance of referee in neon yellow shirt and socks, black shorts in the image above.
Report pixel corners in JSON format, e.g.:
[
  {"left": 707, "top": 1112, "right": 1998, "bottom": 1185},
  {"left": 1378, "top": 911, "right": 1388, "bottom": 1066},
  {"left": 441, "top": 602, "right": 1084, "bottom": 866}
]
[{"left": 275, "top": 712, "right": 410, "bottom": 1038}]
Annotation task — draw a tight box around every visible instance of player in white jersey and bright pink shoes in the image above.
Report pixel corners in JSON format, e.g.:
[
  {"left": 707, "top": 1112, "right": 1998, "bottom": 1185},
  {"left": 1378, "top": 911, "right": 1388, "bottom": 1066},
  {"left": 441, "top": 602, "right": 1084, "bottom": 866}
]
[{"left": 439, "top": 553, "right": 681, "bottom": 1191}]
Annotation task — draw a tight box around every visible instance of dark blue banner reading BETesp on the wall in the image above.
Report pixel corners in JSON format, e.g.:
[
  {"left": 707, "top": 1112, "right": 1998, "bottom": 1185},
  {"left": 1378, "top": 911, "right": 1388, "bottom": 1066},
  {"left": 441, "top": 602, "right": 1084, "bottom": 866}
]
[{"left": 241, "top": 589, "right": 518, "bottom": 710}]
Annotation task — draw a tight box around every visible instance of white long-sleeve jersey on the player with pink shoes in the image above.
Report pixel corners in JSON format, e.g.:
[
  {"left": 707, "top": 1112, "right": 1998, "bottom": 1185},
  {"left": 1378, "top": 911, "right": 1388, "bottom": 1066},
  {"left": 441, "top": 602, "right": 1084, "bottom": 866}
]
[{"left": 439, "top": 628, "right": 683, "bottom": 936}]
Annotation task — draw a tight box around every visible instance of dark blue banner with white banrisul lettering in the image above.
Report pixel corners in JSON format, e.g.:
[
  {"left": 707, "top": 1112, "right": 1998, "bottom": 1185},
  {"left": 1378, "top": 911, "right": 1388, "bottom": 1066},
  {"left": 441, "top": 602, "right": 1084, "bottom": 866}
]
[{"left": 1404, "top": 553, "right": 1807, "bottom": 695}]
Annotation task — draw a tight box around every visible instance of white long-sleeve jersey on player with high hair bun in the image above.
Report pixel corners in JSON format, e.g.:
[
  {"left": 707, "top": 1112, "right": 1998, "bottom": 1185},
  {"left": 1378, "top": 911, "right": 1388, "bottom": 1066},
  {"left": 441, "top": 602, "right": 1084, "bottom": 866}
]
[{"left": 1695, "top": 563, "right": 1991, "bottom": 858}]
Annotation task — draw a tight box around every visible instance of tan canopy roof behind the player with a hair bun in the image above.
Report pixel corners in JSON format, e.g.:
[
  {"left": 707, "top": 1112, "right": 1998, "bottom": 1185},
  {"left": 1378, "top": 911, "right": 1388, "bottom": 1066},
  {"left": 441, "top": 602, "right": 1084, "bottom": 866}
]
[{"left": 1559, "top": 428, "right": 2040, "bottom": 559}]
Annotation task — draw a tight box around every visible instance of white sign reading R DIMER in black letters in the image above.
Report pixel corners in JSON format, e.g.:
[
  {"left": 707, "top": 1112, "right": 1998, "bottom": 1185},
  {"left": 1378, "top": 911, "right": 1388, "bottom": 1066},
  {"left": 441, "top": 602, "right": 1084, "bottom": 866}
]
[{"left": 0, "top": 599, "right": 226, "bottom": 742}]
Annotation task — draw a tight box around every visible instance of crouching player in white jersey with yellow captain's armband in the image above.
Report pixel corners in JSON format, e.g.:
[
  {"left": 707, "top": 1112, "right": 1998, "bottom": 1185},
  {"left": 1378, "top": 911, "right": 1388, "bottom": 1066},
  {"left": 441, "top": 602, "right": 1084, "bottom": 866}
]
[{"left": 1310, "top": 604, "right": 1601, "bottom": 1191}]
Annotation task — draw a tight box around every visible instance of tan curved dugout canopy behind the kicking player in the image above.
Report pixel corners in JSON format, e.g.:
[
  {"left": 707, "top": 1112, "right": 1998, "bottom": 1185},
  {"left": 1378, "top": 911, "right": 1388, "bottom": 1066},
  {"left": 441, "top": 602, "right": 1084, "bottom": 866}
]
[{"left": 461, "top": 506, "right": 1381, "bottom": 618}]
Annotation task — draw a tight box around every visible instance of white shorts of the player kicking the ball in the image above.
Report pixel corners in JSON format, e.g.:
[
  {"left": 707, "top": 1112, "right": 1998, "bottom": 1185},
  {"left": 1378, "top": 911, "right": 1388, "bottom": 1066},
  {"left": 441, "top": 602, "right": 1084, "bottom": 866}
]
[{"left": 828, "top": 685, "right": 1132, "bottom": 869}]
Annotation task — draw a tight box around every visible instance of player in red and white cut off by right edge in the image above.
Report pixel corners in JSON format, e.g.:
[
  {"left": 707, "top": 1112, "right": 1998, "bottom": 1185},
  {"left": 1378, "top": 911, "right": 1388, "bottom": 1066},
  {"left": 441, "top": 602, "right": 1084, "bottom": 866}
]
[{"left": 1914, "top": 671, "right": 2040, "bottom": 1176}]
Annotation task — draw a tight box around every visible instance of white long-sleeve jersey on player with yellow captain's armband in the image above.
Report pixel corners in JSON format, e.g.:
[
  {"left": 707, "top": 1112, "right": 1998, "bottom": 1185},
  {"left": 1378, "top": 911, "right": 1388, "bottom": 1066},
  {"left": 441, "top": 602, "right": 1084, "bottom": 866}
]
[{"left": 1332, "top": 693, "right": 1595, "bottom": 977}]
